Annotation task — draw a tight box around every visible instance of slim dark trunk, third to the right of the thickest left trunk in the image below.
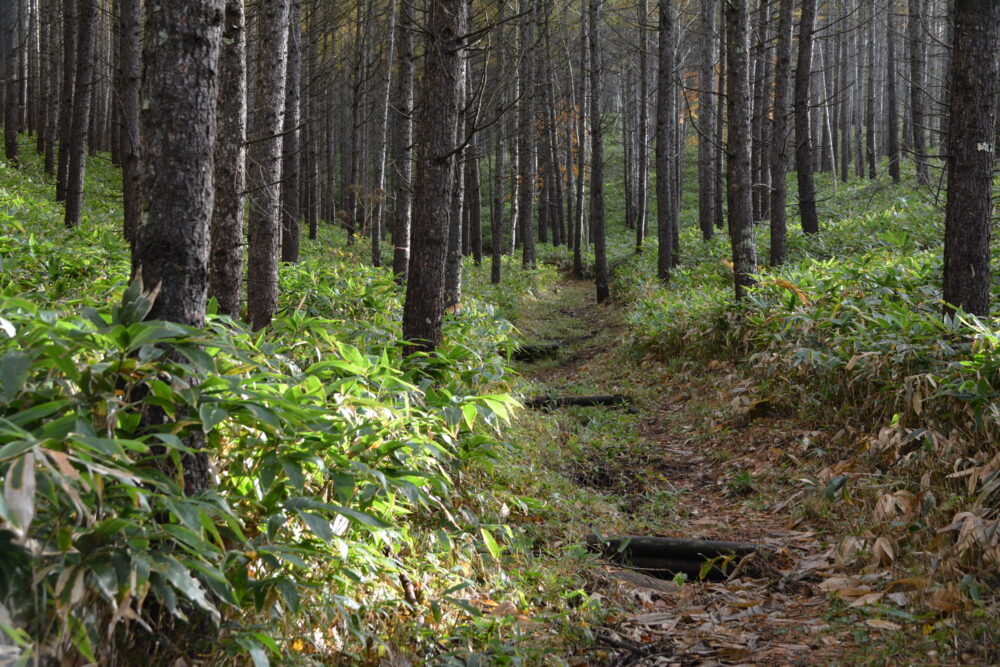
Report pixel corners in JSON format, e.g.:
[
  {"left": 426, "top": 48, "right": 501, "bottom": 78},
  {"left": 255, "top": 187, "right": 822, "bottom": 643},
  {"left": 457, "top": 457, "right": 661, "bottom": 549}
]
[{"left": 281, "top": 0, "right": 302, "bottom": 262}]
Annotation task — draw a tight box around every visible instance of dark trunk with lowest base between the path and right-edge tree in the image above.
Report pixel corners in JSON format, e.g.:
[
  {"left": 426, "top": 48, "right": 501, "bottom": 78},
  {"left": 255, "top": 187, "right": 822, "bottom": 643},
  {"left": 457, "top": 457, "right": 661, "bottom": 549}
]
[{"left": 725, "top": 0, "right": 752, "bottom": 301}]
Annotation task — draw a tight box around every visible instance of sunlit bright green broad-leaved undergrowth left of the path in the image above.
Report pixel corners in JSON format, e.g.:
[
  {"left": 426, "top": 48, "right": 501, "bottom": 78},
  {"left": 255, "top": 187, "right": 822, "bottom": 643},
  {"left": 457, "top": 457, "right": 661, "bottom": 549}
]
[{"left": 0, "top": 140, "right": 599, "bottom": 665}]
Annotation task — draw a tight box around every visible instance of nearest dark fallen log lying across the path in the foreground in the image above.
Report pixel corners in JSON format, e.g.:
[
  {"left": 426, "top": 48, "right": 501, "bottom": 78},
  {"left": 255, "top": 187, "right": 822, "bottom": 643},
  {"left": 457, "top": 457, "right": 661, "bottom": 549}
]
[{"left": 587, "top": 535, "right": 761, "bottom": 580}]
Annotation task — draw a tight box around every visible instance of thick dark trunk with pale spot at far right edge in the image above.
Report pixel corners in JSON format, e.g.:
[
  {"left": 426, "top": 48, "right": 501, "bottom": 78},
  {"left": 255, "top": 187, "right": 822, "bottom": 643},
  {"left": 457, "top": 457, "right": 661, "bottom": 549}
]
[{"left": 944, "top": 0, "right": 1000, "bottom": 316}]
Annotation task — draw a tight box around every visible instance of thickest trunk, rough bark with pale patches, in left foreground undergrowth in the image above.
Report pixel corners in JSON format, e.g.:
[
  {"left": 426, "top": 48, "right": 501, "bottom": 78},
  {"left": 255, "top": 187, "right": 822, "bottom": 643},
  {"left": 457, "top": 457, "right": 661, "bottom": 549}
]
[{"left": 138, "top": 0, "right": 223, "bottom": 495}]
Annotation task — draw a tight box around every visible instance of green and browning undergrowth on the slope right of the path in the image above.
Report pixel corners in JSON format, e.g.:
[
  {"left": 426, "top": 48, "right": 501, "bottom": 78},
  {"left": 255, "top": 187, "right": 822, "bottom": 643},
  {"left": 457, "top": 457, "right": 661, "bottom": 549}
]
[{"left": 615, "top": 162, "right": 1000, "bottom": 600}]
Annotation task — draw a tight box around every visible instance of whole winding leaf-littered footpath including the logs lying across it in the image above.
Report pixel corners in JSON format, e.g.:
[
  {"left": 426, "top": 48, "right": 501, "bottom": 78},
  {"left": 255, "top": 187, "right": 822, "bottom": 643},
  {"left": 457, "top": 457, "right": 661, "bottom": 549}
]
[{"left": 508, "top": 281, "right": 894, "bottom": 665}]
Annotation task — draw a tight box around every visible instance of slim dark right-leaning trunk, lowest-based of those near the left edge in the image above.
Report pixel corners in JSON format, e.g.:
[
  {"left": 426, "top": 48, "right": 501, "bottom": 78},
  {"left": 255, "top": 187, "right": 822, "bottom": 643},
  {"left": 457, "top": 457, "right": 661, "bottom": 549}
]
[{"left": 65, "top": 0, "right": 98, "bottom": 227}]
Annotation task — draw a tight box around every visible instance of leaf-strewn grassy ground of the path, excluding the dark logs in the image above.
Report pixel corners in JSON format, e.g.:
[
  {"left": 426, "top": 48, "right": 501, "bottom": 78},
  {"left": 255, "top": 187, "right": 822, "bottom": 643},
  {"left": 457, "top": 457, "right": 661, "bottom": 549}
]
[{"left": 508, "top": 281, "right": 978, "bottom": 665}]
